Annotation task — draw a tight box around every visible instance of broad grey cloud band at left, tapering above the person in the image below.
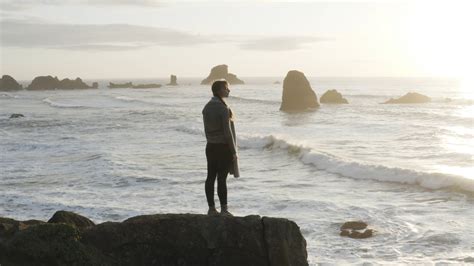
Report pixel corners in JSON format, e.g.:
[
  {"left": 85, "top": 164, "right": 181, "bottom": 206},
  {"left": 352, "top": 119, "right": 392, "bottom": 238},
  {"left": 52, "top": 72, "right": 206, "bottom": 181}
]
[{"left": 0, "top": 20, "right": 211, "bottom": 50}]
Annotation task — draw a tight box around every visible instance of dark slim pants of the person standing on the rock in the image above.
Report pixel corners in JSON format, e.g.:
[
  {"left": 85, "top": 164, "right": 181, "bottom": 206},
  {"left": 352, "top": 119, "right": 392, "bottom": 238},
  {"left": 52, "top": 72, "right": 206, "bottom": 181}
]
[{"left": 205, "top": 143, "right": 233, "bottom": 207}]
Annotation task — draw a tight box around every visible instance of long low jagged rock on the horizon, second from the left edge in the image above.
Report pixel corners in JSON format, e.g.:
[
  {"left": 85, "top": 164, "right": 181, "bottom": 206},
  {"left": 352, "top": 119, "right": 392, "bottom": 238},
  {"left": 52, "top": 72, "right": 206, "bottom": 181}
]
[{"left": 26, "top": 76, "right": 94, "bottom": 90}]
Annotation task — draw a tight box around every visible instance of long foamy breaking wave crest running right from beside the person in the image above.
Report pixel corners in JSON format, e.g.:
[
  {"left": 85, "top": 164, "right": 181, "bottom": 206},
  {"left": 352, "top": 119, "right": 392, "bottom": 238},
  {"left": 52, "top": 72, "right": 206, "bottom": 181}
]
[{"left": 239, "top": 135, "right": 474, "bottom": 192}]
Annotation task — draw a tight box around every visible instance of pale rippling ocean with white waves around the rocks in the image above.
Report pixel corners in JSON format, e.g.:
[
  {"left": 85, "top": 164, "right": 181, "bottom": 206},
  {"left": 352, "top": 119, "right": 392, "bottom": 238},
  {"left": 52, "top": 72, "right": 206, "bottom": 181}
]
[{"left": 0, "top": 77, "right": 474, "bottom": 265}]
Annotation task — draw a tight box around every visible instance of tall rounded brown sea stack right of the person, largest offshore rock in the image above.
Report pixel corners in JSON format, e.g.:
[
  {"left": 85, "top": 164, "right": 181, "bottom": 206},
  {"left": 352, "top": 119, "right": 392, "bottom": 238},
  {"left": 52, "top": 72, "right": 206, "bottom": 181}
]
[{"left": 280, "top": 70, "right": 319, "bottom": 111}]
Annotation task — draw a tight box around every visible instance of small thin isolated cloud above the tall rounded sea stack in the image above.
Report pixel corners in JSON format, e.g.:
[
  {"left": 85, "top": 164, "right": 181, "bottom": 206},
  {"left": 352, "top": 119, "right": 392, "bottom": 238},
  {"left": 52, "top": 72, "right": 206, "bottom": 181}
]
[{"left": 240, "top": 36, "right": 331, "bottom": 51}]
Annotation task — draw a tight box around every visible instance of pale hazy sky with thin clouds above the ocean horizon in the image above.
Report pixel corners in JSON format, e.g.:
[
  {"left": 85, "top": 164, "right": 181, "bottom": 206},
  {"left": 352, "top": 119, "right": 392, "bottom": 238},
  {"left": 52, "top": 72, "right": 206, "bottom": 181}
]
[{"left": 0, "top": 0, "right": 474, "bottom": 80}]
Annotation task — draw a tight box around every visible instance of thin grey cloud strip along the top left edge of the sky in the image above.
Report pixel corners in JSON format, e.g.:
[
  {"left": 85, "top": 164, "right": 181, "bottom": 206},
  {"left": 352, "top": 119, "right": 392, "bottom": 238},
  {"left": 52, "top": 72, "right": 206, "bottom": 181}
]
[{"left": 0, "top": 0, "right": 163, "bottom": 11}]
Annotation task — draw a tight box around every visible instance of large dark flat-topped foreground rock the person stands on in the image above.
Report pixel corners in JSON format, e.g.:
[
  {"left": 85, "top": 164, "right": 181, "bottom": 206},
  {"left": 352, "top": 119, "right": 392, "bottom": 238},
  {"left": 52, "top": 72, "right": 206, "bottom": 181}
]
[{"left": 0, "top": 211, "right": 308, "bottom": 266}]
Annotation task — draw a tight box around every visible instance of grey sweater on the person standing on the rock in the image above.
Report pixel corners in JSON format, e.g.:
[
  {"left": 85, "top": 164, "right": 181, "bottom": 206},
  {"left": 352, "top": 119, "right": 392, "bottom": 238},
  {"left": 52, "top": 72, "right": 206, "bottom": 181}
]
[{"left": 202, "top": 96, "right": 237, "bottom": 154}]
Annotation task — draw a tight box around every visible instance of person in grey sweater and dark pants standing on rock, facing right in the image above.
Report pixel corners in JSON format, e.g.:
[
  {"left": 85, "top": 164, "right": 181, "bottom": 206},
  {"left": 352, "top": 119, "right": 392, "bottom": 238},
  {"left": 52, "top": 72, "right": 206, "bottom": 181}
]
[{"left": 202, "top": 80, "right": 239, "bottom": 216}]
